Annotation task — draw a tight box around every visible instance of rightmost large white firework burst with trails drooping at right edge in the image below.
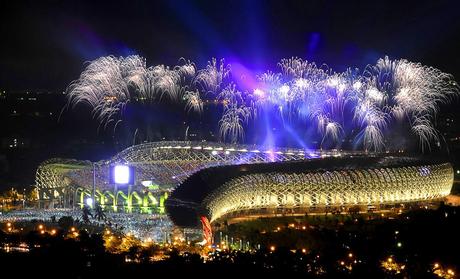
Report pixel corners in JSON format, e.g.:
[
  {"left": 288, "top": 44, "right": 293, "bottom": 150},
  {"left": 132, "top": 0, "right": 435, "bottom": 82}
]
[{"left": 361, "top": 57, "right": 458, "bottom": 150}]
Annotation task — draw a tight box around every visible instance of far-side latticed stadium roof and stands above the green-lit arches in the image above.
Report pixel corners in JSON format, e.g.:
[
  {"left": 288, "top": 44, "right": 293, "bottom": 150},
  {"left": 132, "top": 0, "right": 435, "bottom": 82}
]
[{"left": 36, "top": 141, "right": 344, "bottom": 198}]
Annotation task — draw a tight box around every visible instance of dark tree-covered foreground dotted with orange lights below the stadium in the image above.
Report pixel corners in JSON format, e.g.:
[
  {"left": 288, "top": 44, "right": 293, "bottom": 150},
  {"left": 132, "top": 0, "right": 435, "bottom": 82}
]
[{"left": 0, "top": 205, "right": 460, "bottom": 278}]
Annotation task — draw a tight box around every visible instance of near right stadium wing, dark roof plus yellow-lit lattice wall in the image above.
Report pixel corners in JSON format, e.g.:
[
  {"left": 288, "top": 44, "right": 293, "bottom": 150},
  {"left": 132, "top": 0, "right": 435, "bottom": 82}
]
[{"left": 166, "top": 155, "right": 454, "bottom": 226}]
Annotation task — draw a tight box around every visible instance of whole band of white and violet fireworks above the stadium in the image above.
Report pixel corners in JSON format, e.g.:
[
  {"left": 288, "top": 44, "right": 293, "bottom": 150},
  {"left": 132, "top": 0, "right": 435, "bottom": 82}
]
[{"left": 67, "top": 55, "right": 459, "bottom": 151}]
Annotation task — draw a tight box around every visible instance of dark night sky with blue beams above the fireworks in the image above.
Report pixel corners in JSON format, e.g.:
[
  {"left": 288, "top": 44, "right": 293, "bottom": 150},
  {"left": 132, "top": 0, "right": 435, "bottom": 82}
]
[{"left": 0, "top": 0, "right": 460, "bottom": 90}]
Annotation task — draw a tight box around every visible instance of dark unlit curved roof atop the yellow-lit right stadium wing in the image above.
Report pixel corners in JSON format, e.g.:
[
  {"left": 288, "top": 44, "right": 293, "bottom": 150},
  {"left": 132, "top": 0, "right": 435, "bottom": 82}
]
[{"left": 166, "top": 155, "right": 445, "bottom": 227}]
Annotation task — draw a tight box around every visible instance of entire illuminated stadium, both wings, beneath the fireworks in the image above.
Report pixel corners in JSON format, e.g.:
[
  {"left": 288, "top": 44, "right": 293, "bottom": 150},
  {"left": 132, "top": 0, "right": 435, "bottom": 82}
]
[{"left": 36, "top": 141, "right": 453, "bottom": 226}]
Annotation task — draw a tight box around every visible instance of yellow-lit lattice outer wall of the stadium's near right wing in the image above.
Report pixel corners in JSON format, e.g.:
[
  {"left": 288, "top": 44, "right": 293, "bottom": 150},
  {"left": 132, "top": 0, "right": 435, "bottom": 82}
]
[{"left": 205, "top": 163, "right": 453, "bottom": 222}]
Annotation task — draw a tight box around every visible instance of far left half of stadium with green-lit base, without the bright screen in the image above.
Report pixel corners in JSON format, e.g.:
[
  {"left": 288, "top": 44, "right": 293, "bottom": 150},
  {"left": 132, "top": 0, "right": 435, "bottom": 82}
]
[{"left": 36, "top": 141, "right": 320, "bottom": 213}]
